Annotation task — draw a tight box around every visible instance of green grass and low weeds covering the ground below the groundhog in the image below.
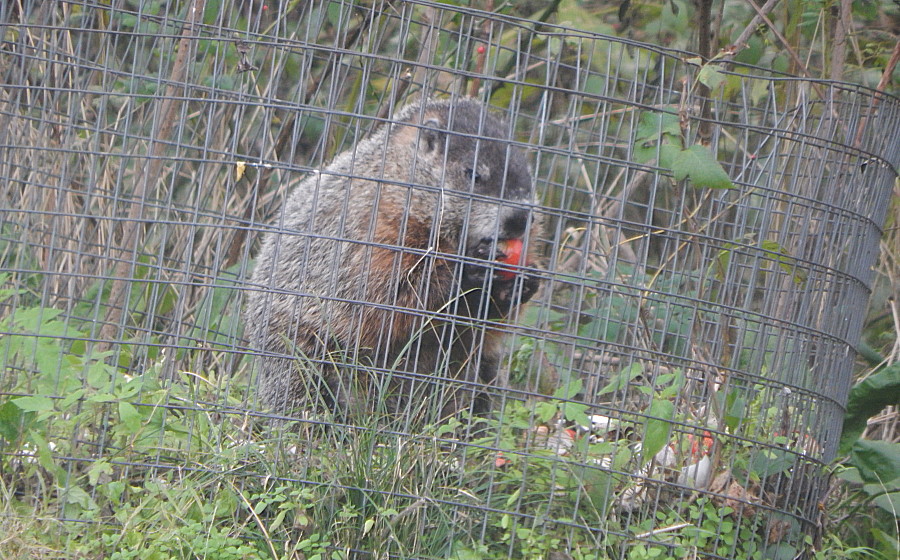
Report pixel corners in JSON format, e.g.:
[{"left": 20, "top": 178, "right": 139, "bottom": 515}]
[{"left": 0, "top": 300, "right": 892, "bottom": 560}]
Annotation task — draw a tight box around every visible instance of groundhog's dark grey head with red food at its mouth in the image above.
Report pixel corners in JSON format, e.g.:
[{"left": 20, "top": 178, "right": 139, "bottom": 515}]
[{"left": 392, "top": 99, "right": 534, "bottom": 274}]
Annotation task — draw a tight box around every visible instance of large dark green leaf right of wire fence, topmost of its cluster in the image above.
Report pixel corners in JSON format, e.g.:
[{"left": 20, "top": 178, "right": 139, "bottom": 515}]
[{"left": 840, "top": 362, "right": 900, "bottom": 455}]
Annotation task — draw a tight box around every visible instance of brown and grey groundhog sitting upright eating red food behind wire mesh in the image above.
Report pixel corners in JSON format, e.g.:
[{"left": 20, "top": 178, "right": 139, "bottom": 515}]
[{"left": 246, "top": 99, "right": 539, "bottom": 417}]
